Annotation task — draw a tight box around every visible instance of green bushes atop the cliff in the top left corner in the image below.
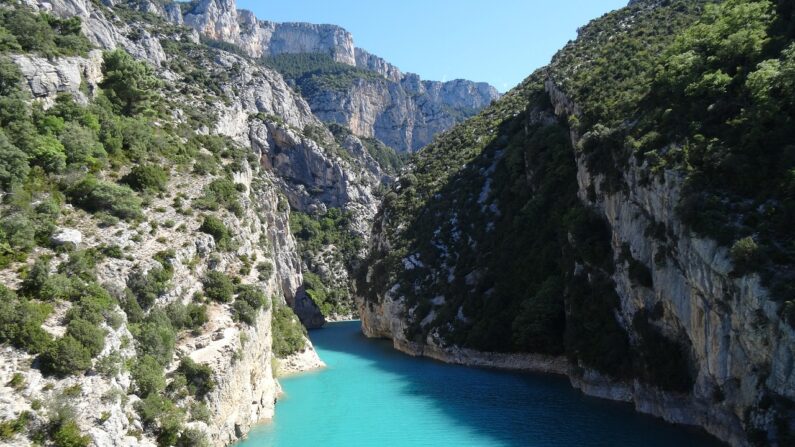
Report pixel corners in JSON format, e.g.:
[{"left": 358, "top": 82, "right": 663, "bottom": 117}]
[{"left": 0, "top": 7, "right": 91, "bottom": 57}]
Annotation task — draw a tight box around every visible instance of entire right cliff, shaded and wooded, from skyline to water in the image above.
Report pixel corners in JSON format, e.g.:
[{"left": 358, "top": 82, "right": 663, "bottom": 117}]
[{"left": 360, "top": 0, "right": 795, "bottom": 446}]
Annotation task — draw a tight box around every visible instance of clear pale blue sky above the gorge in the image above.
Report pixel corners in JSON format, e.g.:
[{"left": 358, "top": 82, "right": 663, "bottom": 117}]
[{"left": 237, "top": 0, "right": 628, "bottom": 92}]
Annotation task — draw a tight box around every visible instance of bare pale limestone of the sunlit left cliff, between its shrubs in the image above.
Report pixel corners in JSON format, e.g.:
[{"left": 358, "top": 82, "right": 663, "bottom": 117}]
[{"left": 0, "top": 0, "right": 382, "bottom": 446}]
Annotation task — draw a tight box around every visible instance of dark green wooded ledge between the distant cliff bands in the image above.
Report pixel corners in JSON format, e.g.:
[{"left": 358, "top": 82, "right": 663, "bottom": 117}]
[{"left": 262, "top": 53, "right": 386, "bottom": 96}]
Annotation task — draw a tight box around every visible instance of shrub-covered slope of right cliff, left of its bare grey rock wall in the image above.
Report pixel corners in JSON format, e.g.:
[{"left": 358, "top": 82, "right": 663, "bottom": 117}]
[{"left": 360, "top": 1, "right": 760, "bottom": 396}]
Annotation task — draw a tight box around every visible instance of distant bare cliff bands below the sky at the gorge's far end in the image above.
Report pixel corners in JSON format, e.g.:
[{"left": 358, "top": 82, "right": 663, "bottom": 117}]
[{"left": 170, "top": 0, "right": 500, "bottom": 152}]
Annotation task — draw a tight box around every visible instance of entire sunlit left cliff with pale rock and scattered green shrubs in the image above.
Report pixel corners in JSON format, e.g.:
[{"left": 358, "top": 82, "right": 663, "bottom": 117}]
[{"left": 0, "top": 0, "right": 404, "bottom": 446}]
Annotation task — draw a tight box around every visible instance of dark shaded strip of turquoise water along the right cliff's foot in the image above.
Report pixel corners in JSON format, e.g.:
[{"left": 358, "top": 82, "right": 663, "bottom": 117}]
[{"left": 310, "top": 322, "right": 721, "bottom": 447}]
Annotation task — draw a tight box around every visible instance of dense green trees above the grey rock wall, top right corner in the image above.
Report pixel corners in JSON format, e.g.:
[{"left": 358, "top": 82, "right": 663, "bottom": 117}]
[{"left": 634, "top": 0, "right": 795, "bottom": 300}]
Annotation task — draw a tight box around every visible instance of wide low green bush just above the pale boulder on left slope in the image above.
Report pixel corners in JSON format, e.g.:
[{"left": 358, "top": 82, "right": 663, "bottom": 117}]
[{"left": 66, "top": 175, "right": 141, "bottom": 219}]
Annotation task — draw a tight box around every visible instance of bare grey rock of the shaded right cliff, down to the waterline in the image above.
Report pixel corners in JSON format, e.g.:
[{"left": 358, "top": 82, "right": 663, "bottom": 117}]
[{"left": 360, "top": 68, "right": 795, "bottom": 446}]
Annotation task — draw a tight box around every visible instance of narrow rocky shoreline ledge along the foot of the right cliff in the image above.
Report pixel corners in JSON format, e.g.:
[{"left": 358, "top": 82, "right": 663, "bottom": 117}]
[{"left": 380, "top": 338, "right": 749, "bottom": 447}]
